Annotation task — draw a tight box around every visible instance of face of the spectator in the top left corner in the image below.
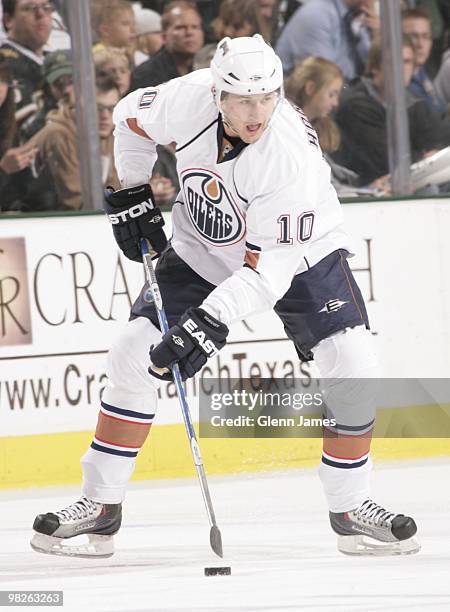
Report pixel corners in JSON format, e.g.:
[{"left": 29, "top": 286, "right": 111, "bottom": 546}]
[{"left": 5, "top": 0, "right": 53, "bottom": 51}]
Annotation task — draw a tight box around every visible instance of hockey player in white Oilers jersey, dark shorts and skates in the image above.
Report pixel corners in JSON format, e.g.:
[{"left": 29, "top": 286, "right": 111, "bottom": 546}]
[{"left": 32, "top": 35, "right": 419, "bottom": 556}]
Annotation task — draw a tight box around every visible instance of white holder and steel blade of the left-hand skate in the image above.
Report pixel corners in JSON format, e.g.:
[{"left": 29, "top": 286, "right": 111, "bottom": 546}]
[{"left": 30, "top": 532, "right": 114, "bottom": 559}]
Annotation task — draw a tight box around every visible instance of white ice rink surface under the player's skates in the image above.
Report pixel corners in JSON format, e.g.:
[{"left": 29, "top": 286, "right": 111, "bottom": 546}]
[{"left": 0, "top": 459, "right": 450, "bottom": 612}]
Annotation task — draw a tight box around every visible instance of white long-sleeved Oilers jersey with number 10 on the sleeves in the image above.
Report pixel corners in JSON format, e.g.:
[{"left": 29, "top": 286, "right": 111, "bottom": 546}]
[{"left": 114, "top": 69, "right": 351, "bottom": 324}]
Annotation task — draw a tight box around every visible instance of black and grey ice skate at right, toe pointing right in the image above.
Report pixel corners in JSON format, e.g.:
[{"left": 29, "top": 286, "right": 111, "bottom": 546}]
[{"left": 330, "top": 499, "right": 420, "bottom": 555}]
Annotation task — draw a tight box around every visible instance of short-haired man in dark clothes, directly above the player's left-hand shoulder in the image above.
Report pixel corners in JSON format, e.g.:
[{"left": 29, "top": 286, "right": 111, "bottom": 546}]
[{"left": 131, "top": 0, "right": 204, "bottom": 91}]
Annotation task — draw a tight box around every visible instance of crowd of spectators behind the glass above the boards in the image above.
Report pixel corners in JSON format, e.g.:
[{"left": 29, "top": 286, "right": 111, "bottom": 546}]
[{"left": 0, "top": 0, "right": 450, "bottom": 212}]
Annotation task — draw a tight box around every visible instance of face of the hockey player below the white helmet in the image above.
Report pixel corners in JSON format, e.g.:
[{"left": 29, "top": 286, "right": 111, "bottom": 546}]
[{"left": 220, "top": 91, "right": 280, "bottom": 144}]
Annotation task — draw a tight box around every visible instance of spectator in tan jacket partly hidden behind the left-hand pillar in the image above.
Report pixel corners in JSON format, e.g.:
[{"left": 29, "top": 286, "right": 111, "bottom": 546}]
[{"left": 31, "top": 77, "right": 120, "bottom": 210}]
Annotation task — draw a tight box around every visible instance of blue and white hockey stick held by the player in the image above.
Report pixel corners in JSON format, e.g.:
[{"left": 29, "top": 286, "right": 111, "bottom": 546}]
[{"left": 141, "top": 238, "right": 223, "bottom": 557}]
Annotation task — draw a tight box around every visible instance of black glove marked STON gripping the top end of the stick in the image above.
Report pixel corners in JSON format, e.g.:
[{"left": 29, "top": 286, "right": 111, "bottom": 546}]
[{"left": 104, "top": 185, "right": 167, "bottom": 262}]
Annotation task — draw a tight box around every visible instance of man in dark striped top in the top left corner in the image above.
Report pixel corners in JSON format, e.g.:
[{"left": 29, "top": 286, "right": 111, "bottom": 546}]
[{"left": 0, "top": 0, "right": 53, "bottom": 122}]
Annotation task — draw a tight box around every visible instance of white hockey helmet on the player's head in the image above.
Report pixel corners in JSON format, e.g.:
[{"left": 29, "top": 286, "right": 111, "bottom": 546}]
[{"left": 211, "top": 34, "right": 283, "bottom": 100}]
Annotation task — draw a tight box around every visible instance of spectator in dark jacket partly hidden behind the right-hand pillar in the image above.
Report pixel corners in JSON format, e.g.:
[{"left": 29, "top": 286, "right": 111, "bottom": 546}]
[{"left": 333, "top": 36, "right": 444, "bottom": 184}]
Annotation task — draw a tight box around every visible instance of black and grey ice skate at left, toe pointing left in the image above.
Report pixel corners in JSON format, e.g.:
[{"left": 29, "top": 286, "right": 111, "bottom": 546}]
[{"left": 30, "top": 497, "right": 122, "bottom": 557}]
